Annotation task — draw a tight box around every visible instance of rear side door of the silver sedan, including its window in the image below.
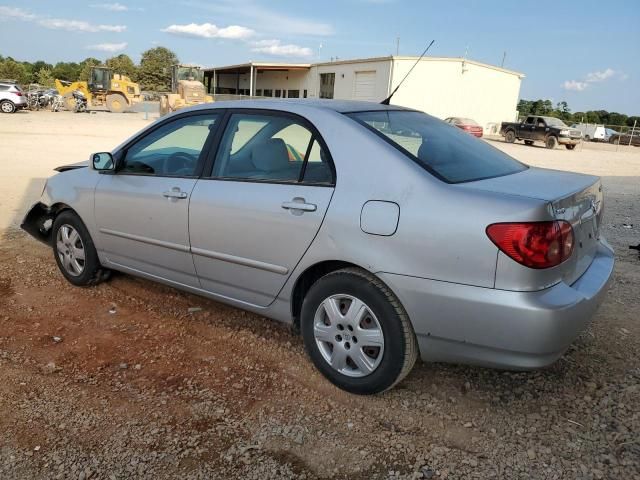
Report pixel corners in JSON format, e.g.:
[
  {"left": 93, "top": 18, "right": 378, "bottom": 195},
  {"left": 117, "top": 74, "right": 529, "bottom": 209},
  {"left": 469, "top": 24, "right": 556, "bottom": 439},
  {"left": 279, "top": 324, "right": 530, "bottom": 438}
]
[{"left": 189, "top": 111, "right": 334, "bottom": 306}]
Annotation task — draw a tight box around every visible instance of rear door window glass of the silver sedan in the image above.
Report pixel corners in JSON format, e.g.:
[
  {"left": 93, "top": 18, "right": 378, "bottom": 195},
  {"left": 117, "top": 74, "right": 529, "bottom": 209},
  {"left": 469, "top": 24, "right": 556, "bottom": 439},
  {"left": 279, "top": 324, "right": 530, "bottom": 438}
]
[{"left": 213, "top": 113, "right": 332, "bottom": 183}]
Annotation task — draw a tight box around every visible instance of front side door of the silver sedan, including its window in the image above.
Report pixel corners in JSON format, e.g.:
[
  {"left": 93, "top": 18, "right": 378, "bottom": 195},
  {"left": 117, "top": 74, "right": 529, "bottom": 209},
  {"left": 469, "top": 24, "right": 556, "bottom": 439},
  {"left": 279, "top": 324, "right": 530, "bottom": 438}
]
[{"left": 94, "top": 113, "right": 219, "bottom": 287}]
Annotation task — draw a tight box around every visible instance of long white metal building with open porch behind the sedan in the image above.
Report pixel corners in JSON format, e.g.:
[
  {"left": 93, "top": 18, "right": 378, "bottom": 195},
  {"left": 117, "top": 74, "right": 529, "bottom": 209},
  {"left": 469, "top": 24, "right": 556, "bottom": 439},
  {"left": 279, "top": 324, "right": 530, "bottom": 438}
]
[{"left": 205, "top": 56, "right": 524, "bottom": 133}]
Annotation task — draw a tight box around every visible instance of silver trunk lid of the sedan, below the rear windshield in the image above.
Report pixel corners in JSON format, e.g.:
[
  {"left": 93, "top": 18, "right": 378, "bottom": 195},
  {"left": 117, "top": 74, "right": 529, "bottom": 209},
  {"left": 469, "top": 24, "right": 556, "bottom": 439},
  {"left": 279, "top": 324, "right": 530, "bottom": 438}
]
[{"left": 459, "top": 167, "right": 603, "bottom": 285}]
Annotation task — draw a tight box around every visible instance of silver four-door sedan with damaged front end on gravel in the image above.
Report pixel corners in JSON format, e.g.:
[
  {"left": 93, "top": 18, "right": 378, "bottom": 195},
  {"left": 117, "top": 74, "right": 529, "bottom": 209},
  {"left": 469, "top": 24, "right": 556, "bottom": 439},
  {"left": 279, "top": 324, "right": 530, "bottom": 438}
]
[{"left": 22, "top": 100, "right": 614, "bottom": 394}]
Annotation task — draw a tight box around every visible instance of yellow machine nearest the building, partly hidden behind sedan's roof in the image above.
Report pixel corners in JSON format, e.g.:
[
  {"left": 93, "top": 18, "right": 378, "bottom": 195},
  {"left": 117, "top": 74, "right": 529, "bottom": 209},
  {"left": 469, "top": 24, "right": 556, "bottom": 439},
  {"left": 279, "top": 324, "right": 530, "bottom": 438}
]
[{"left": 160, "top": 65, "right": 213, "bottom": 116}]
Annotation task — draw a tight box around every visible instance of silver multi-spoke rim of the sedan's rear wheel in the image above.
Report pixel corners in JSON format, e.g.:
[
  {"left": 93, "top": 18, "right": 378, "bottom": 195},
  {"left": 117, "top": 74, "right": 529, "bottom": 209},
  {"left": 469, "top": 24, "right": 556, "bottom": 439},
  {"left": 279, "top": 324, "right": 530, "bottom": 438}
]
[{"left": 313, "top": 295, "right": 384, "bottom": 378}]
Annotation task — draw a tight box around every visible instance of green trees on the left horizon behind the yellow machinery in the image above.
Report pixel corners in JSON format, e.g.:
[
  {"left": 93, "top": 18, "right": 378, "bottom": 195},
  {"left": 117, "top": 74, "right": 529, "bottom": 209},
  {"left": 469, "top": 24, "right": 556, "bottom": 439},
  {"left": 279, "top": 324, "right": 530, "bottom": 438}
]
[{"left": 0, "top": 47, "right": 179, "bottom": 92}]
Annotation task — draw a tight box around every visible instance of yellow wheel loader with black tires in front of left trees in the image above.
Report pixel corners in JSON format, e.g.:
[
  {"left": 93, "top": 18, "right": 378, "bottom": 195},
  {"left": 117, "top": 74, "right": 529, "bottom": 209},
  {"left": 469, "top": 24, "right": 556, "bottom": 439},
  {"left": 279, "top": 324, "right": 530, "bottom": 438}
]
[{"left": 56, "top": 67, "right": 142, "bottom": 113}]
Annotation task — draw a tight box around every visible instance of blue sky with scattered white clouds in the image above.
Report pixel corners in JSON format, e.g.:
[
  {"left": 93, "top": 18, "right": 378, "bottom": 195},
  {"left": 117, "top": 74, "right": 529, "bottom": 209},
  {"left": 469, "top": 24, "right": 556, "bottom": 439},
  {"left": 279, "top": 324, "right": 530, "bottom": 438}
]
[{"left": 0, "top": 0, "right": 640, "bottom": 115}]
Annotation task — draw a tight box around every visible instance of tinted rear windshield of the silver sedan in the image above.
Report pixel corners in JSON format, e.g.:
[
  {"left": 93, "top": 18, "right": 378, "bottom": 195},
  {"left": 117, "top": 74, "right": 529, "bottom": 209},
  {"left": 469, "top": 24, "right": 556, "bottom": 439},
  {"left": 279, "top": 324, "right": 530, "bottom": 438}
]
[{"left": 347, "top": 110, "right": 528, "bottom": 183}]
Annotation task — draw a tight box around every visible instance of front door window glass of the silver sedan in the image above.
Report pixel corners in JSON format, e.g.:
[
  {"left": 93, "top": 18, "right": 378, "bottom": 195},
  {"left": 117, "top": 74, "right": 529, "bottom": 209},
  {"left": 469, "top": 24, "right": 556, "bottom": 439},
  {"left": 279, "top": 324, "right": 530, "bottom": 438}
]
[{"left": 119, "top": 114, "right": 218, "bottom": 177}]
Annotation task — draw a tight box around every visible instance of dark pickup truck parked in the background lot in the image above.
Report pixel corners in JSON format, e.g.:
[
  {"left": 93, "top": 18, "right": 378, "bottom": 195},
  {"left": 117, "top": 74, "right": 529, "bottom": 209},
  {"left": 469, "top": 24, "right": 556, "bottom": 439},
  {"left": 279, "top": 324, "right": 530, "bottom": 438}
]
[{"left": 500, "top": 115, "right": 582, "bottom": 150}]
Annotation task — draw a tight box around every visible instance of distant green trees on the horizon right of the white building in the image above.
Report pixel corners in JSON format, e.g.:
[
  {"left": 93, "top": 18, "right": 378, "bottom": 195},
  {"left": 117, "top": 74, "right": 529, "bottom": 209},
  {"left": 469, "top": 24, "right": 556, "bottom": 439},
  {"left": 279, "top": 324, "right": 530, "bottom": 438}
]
[{"left": 518, "top": 100, "right": 640, "bottom": 127}]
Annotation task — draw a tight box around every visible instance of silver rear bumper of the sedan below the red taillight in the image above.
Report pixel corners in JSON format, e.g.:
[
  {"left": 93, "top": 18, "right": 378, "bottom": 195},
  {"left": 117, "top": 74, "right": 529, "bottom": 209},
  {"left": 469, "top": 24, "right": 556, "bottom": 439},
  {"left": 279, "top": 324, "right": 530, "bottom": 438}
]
[{"left": 379, "top": 240, "right": 614, "bottom": 370}]
